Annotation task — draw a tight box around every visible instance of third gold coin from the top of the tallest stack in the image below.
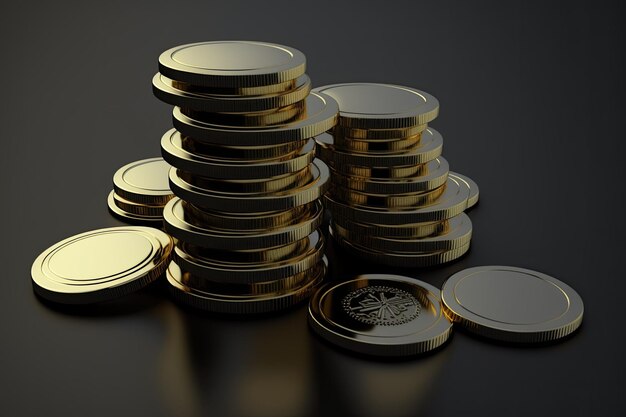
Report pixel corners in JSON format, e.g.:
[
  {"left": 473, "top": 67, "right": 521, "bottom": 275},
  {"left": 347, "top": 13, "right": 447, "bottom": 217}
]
[{"left": 181, "top": 99, "right": 305, "bottom": 126}]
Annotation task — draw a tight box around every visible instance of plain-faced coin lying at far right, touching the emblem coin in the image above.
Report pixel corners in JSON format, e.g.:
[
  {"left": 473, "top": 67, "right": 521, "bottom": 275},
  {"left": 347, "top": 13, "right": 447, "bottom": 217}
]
[{"left": 442, "top": 266, "right": 584, "bottom": 343}]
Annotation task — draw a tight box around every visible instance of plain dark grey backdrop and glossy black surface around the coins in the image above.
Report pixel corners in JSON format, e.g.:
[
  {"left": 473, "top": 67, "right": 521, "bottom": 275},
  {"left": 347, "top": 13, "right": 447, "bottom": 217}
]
[{"left": 0, "top": 1, "right": 626, "bottom": 417}]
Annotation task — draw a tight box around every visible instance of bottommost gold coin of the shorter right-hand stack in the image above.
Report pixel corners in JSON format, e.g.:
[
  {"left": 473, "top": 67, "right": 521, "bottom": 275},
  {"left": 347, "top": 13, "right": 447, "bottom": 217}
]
[{"left": 330, "top": 228, "right": 470, "bottom": 268}]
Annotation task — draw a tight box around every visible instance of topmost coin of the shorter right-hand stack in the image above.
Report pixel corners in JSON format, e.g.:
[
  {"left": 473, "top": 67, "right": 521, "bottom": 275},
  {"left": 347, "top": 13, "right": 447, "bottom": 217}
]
[{"left": 313, "top": 83, "right": 439, "bottom": 129}]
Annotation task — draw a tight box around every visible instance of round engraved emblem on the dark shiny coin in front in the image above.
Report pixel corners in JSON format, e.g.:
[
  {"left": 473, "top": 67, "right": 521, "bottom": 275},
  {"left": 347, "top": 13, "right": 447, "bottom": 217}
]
[{"left": 342, "top": 285, "right": 422, "bottom": 326}]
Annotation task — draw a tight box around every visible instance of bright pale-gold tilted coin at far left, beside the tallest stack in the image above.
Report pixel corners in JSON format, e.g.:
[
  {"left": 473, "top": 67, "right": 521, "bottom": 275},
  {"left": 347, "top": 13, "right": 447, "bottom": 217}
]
[{"left": 31, "top": 226, "right": 174, "bottom": 304}]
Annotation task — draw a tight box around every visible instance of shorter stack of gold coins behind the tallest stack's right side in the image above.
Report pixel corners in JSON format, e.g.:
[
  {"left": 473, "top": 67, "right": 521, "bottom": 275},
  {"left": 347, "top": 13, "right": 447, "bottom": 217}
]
[{"left": 314, "top": 83, "right": 478, "bottom": 267}]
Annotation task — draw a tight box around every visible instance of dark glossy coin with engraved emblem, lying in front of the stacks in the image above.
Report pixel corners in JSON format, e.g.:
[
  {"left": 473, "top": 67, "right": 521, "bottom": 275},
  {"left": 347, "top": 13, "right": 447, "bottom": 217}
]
[{"left": 308, "top": 274, "right": 452, "bottom": 356}]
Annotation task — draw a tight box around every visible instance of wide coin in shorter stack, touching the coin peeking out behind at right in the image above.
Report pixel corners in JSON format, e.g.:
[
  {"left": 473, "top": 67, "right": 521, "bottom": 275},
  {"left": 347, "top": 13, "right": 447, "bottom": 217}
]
[{"left": 325, "top": 178, "right": 469, "bottom": 226}]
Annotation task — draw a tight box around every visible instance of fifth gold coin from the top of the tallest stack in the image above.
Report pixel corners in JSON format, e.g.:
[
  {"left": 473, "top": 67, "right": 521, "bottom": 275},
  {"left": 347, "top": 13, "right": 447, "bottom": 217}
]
[{"left": 177, "top": 132, "right": 311, "bottom": 162}]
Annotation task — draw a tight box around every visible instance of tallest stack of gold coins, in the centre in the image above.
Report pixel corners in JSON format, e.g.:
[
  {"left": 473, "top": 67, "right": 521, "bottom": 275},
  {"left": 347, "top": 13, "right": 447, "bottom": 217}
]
[{"left": 152, "top": 41, "right": 339, "bottom": 313}]
